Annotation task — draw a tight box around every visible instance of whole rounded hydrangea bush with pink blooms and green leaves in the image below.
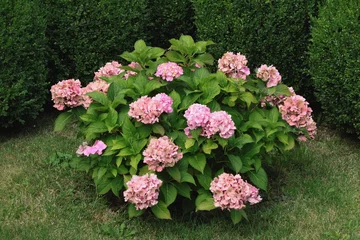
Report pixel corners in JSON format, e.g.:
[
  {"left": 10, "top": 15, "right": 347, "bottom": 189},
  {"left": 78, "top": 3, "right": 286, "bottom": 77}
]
[{"left": 51, "top": 36, "right": 316, "bottom": 223}]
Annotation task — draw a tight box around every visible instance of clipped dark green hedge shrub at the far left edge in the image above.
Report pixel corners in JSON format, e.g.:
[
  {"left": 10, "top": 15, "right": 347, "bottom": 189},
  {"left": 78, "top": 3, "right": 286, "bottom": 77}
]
[{"left": 0, "top": 0, "right": 48, "bottom": 128}]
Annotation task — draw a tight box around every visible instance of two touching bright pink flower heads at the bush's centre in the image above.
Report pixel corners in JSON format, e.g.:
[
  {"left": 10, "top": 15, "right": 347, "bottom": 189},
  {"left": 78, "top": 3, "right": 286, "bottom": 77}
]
[{"left": 184, "top": 103, "right": 236, "bottom": 138}]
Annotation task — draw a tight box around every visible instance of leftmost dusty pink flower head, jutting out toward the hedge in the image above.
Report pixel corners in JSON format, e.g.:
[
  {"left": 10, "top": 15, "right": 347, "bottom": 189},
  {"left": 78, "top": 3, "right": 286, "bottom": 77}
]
[{"left": 50, "top": 79, "right": 82, "bottom": 111}]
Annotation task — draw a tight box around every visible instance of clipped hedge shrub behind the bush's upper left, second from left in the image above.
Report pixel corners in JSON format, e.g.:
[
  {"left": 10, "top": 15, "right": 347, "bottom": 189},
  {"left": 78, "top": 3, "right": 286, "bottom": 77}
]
[{"left": 46, "top": 0, "right": 148, "bottom": 83}]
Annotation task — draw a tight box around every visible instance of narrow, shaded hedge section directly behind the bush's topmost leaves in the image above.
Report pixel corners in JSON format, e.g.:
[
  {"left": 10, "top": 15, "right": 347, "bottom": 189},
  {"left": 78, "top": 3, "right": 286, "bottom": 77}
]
[{"left": 146, "top": 0, "right": 195, "bottom": 48}]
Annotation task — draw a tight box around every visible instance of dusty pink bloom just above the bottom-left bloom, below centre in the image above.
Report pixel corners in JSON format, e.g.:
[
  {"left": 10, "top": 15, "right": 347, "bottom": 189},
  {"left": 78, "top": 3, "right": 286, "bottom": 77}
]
[{"left": 143, "top": 136, "right": 183, "bottom": 172}]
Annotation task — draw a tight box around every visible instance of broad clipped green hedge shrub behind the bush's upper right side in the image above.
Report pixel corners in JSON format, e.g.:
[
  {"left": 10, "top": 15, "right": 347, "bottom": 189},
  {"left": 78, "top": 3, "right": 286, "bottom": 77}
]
[{"left": 192, "top": 0, "right": 316, "bottom": 98}]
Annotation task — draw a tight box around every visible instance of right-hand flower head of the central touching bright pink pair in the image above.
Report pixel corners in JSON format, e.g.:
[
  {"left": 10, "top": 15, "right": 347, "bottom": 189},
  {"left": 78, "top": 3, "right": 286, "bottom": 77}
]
[{"left": 202, "top": 111, "right": 236, "bottom": 138}]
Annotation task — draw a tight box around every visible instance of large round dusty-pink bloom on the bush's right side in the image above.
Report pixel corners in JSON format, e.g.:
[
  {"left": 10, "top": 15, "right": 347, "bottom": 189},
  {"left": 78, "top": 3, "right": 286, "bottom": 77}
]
[{"left": 279, "top": 95, "right": 312, "bottom": 128}]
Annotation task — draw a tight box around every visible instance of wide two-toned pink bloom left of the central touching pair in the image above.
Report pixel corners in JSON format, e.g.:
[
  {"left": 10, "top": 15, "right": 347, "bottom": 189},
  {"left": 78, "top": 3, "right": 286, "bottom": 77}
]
[{"left": 128, "top": 93, "right": 173, "bottom": 124}]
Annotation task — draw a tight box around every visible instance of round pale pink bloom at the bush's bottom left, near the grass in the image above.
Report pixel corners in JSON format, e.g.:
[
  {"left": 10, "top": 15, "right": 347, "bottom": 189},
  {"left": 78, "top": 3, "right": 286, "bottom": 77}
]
[{"left": 124, "top": 173, "right": 162, "bottom": 210}]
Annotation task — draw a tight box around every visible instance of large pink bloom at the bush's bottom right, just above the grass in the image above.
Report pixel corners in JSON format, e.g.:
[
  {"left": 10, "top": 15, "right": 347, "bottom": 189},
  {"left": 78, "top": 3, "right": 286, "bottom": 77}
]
[{"left": 210, "top": 173, "right": 262, "bottom": 211}]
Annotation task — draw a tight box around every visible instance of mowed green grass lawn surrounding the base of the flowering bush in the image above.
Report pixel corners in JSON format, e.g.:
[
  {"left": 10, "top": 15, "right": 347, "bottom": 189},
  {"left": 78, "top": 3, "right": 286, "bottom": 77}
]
[{"left": 0, "top": 116, "right": 360, "bottom": 240}]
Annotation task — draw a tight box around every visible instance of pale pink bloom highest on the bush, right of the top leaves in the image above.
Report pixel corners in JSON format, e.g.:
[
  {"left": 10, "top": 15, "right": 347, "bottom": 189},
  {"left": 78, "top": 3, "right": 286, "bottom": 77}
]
[{"left": 218, "top": 52, "right": 250, "bottom": 80}]
